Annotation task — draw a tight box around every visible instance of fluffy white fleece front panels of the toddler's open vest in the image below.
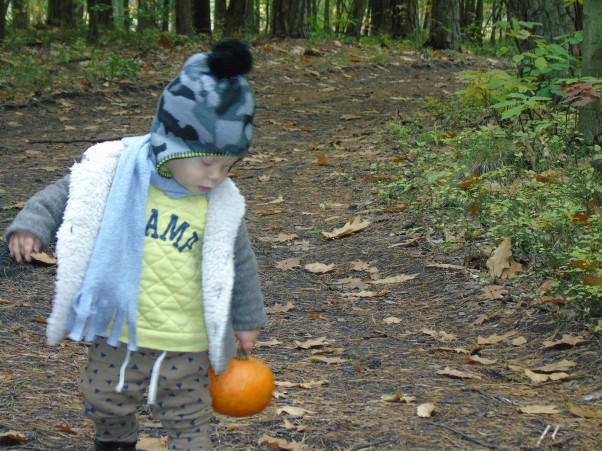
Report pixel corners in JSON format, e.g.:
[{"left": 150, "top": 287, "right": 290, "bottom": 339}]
[{"left": 46, "top": 141, "right": 245, "bottom": 374}]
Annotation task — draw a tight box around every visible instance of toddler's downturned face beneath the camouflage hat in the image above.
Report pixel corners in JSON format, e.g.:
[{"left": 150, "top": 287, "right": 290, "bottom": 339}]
[{"left": 165, "top": 156, "right": 238, "bottom": 193}]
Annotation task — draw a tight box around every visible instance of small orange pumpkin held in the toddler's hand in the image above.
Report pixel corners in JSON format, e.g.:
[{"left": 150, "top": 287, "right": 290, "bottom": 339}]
[{"left": 209, "top": 351, "right": 274, "bottom": 417}]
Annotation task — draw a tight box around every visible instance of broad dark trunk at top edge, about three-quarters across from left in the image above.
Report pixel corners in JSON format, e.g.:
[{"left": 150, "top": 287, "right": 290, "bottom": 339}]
[{"left": 425, "top": 0, "right": 461, "bottom": 51}]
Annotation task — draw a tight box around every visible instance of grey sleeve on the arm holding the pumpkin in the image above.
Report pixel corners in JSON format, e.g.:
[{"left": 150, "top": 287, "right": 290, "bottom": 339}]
[{"left": 232, "top": 220, "right": 268, "bottom": 330}]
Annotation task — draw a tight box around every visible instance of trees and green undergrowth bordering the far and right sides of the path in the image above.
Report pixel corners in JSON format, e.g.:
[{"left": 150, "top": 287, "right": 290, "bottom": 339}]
[{"left": 0, "top": 0, "right": 602, "bottom": 329}]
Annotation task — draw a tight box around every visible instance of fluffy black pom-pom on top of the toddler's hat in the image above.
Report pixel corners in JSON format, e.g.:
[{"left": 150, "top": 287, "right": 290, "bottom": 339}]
[{"left": 207, "top": 39, "right": 253, "bottom": 79}]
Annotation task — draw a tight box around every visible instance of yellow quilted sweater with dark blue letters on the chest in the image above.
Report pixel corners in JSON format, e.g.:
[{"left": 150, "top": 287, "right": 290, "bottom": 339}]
[{"left": 120, "top": 185, "right": 208, "bottom": 352}]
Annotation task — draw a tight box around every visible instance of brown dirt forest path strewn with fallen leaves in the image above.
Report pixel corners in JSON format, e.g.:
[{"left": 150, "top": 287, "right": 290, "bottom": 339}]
[{"left": 0, "top": 43, "right": 602, "bottom": 450}]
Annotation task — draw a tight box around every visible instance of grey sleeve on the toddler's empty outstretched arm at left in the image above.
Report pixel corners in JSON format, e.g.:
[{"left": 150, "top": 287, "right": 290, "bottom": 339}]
[{"left": 4, "top": 175, "right": 69, "bottom": 248}]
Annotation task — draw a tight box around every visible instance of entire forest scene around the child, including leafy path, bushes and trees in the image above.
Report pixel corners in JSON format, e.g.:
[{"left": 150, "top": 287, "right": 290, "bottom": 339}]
[{"left": 0, "top": 0, "right": 602, "bottom": 450}]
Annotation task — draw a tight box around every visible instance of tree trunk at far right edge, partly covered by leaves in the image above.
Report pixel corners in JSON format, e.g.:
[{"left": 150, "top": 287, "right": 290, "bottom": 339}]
[{"left": 579, "top": 0, "right": 602, "bottom": 145}]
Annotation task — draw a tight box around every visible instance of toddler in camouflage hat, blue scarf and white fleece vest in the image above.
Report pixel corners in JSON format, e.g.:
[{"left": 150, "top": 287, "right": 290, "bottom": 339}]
[{"left": 6, "top": 39, "right": 267, "bottom": 451}]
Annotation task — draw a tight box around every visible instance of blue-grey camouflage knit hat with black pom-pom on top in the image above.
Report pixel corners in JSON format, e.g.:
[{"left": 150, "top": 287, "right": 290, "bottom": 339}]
[{"left": 151, "top": 39, "right": 255, "bottom": 177}]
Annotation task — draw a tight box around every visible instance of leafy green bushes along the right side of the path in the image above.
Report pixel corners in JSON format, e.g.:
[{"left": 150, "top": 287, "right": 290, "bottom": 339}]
[{"left": 373, "top": 29, "right": 602, "bottom": 314}]
